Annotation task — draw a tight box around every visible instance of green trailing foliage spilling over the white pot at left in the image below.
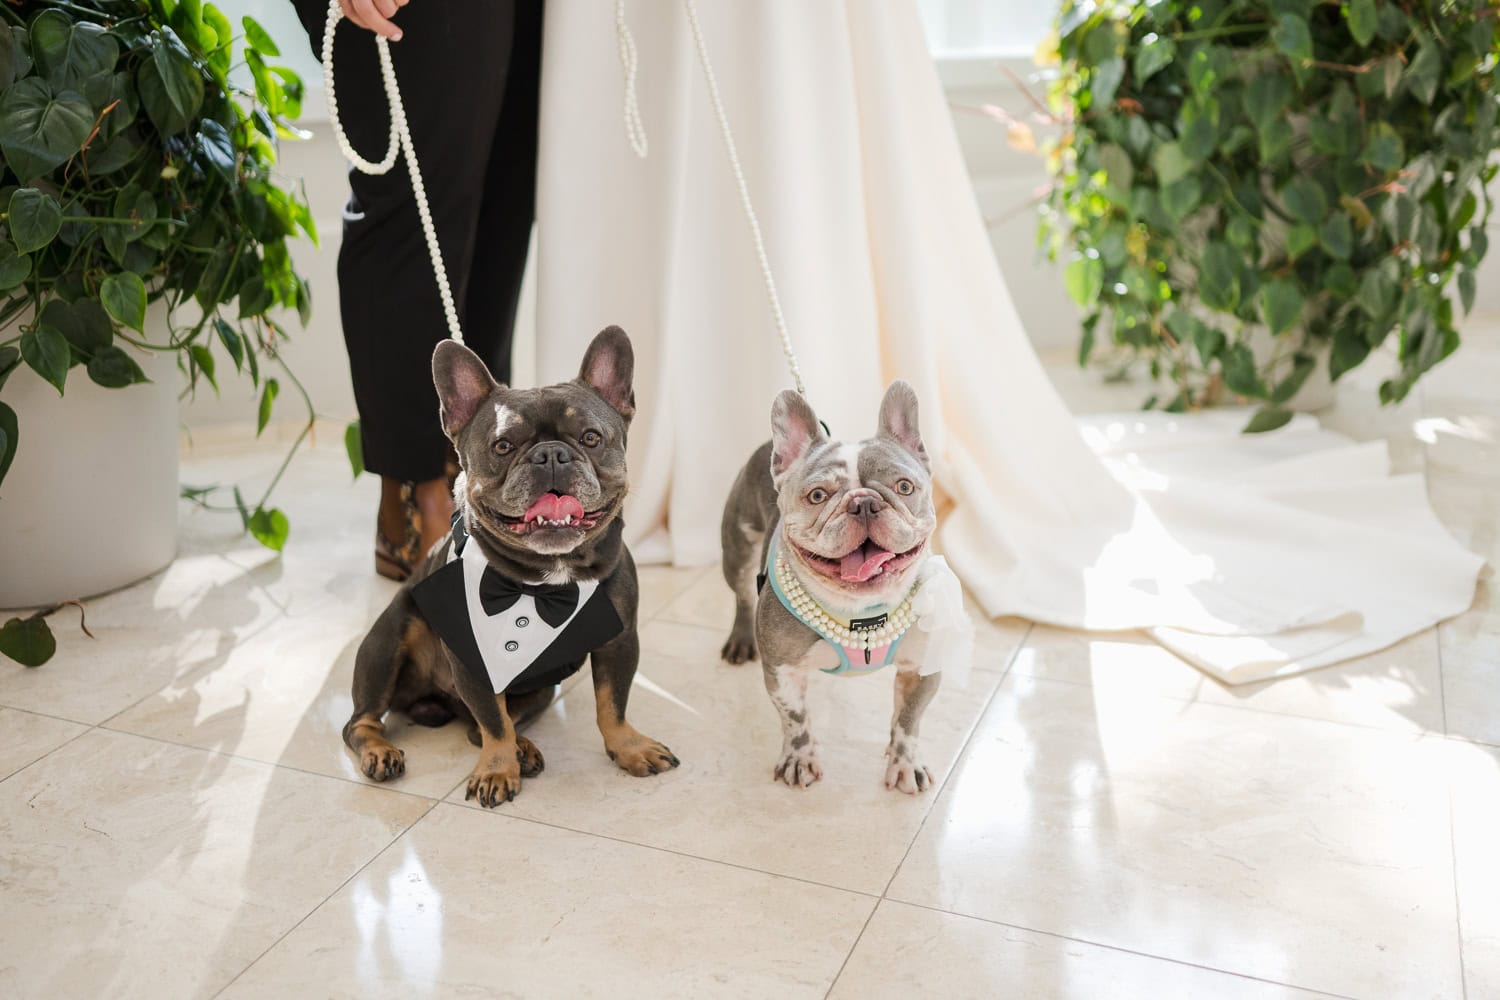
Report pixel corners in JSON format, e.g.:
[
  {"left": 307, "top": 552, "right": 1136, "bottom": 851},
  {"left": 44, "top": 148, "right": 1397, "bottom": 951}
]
[{"left": 0, "top": 0, "right": 317, "bottom": 671}]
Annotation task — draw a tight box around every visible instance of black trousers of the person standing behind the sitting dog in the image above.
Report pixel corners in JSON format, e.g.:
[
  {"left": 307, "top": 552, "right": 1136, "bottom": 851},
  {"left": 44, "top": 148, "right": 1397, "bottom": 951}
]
[{"left": 296, "top": 0, "right": 543, "bottom": 481}]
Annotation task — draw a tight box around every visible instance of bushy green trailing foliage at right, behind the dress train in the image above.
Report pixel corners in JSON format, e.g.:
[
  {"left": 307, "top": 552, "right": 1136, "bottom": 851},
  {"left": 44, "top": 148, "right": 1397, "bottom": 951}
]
[{"left": 1043, "top": 0, "right": 1500, "bottom": 430}]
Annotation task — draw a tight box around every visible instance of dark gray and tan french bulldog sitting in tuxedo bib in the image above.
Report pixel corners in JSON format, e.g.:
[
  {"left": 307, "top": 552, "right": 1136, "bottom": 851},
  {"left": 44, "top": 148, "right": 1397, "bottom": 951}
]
[{"left": 344, "top": 327, "right": 678, "bottom": 807}]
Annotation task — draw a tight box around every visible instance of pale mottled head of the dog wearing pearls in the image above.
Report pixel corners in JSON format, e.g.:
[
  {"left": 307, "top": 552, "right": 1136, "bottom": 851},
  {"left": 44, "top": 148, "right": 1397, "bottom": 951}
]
[{"left": 771, "top": 382, "right": 938, "bottom": 606}]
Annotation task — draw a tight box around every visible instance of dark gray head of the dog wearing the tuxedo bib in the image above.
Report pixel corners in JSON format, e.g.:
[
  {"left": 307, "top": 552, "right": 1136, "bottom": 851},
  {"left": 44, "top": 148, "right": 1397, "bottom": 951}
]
[{"left": 432, "top": 327, "right": 635, "bottom": 556}]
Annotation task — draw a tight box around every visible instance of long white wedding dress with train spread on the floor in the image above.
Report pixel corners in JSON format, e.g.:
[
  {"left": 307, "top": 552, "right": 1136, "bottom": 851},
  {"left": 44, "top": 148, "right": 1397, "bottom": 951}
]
[{"left": 522, "top": 0, "right": 1482, "bottom": 684}]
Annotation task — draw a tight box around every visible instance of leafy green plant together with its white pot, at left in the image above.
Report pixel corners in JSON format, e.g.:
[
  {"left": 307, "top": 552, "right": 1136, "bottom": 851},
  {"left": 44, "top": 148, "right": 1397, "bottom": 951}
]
[{"left": 0, "top": 0, "right": 317, "bottom": 663}]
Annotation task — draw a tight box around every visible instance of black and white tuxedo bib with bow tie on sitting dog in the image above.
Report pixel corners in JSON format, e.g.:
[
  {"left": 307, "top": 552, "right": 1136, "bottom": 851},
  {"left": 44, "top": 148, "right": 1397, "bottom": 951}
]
[{"left": 411, "top": 516, "right": 626, "bottom": 694}]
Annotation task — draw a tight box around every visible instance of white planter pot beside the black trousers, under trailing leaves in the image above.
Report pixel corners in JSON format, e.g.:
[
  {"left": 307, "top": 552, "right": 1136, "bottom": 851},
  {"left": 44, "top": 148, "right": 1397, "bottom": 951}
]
[{"left": 0, "top": 309, "right": 179, "bottom": 609}]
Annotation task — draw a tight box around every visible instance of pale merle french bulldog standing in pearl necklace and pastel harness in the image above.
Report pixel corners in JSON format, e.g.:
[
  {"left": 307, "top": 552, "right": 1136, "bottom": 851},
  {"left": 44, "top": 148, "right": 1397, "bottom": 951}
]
[{"left": 722, "top": 381, "right": 941, "bottom": 793}]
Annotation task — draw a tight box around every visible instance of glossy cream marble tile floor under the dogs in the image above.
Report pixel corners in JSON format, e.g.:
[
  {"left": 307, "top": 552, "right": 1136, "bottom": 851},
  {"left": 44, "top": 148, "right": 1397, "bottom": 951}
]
[{"left": 0, "top": 336, "right": 1500, "bottom": 1000}]
